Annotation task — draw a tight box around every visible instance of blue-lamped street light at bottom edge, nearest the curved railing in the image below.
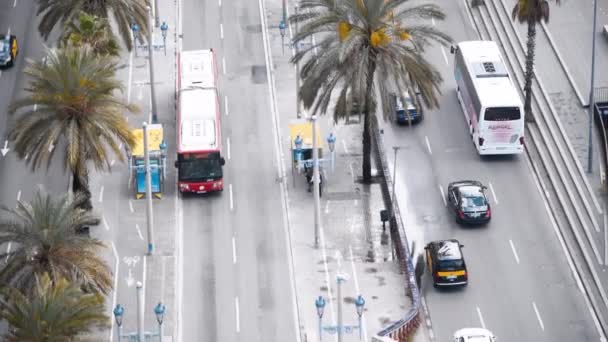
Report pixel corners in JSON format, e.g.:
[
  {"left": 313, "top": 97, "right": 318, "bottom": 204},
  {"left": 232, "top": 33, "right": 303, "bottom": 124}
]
[{"left": 315, "top": 275, "right": 365, "bottom": 342}]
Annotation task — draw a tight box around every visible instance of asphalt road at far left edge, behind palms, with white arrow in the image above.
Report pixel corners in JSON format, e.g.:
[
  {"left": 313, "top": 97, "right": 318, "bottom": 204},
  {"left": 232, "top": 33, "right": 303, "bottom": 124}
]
[{"left": 0, "top": 0, "right": 68, "bottom": 206}]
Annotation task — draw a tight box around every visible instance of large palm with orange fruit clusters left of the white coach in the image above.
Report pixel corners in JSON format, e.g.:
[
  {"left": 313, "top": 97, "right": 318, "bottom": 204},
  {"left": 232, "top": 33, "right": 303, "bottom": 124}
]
[{"left": 290, "top": 0, "right": 451, "bottom": 182}]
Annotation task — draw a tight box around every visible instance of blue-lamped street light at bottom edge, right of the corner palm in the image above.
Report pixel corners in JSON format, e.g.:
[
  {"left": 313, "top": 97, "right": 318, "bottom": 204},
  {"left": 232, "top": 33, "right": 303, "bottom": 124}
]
[{"left": 113, "top": 282, "right": 166, "bottom": 342}]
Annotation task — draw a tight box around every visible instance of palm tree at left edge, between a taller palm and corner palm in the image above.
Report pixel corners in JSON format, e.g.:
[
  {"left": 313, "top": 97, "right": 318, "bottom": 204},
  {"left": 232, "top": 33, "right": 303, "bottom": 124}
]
[{"left": 0, "top": 192, "right": 112, "bottom": 293}]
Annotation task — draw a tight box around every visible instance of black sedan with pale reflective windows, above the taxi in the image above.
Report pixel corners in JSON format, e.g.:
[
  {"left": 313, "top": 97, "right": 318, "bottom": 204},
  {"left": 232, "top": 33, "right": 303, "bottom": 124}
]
[{"left": 447, "top": 180, "right": 492, "bottom": 224}]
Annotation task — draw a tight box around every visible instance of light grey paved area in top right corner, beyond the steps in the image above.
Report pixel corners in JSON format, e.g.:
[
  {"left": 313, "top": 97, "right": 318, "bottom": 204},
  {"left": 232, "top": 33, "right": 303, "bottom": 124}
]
[{"left": 547, "top": 1, "right": 608, "bottom": 93}]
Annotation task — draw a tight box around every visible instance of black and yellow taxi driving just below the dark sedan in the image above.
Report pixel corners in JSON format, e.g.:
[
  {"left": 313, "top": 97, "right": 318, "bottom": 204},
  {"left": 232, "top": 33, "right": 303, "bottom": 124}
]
[{"left": 424, "top": 239, "right": 469, "bottom": 287}]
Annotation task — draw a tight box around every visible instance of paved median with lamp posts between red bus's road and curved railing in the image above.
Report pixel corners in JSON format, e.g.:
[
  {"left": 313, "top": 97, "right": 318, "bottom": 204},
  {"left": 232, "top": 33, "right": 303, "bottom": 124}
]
[{"left": 266, "top": 0, "right": 411, "bottom": 341}]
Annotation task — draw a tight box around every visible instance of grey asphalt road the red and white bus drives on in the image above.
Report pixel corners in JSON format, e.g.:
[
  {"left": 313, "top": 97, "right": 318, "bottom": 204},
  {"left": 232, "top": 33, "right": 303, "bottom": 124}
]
[{"left": 181, "top": 0, "right": 296, "bottom": 341}]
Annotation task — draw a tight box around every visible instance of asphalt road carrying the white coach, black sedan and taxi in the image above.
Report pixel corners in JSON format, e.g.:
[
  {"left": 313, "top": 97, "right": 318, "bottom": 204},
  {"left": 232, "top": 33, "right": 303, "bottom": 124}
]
[{"left": 384, "top": 1, "right": 599, "bottom": 341}]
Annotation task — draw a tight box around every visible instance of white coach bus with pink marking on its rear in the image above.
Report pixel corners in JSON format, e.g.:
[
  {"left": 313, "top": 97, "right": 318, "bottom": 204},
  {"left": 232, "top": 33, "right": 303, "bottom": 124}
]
[{"left": 451, "top": 41, "right": 524, "bottom": 155}]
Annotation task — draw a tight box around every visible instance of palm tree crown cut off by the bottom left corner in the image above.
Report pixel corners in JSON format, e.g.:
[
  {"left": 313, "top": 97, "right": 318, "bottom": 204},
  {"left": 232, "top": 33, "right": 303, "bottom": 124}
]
[{"left": 0, "top": 273, "right": 109, "bottom": 342}]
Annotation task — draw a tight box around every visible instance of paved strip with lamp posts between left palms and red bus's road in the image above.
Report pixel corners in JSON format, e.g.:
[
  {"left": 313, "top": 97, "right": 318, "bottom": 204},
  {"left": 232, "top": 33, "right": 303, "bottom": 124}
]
[{"left": 90, "top": 1, "right": 178, "bottom": 342}]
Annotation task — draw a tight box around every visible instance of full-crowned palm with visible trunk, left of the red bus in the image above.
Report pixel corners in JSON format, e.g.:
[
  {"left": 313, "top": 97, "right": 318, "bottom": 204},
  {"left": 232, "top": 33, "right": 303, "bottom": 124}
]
[{"left": 9, "top": 47, "right": 137, "bottom": 209}]
